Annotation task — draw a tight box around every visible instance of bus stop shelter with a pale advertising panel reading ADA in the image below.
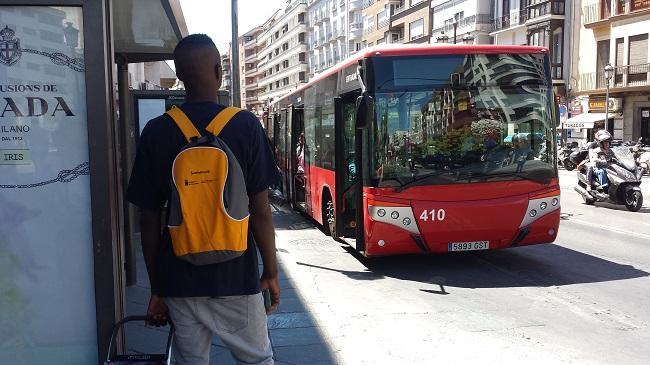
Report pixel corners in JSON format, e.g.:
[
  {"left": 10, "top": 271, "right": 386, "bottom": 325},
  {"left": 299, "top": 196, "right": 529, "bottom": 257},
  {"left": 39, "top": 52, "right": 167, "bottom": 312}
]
[{"left": 0, "top": 0, "right": 187, "bottom": 364}]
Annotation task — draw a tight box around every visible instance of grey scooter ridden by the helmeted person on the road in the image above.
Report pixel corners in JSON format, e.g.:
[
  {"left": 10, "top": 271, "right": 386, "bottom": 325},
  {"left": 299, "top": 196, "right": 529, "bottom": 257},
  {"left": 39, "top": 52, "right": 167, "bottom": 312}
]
[{"left": 574, "top": 146, "right": 644, "bottom": 212}]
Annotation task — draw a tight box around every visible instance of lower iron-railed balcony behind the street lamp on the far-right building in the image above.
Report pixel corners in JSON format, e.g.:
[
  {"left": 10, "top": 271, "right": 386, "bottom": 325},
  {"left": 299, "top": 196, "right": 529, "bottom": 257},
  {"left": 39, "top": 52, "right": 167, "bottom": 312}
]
[{"left": 580, "top": 63, "right": 650, "bottom": 91}]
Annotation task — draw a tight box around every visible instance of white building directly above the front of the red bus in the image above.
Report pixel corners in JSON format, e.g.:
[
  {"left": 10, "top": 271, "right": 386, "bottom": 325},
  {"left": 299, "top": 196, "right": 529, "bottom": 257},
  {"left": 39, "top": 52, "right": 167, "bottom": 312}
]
[{"left": 431, "top": 0, "right": 492, "bottom": 44}]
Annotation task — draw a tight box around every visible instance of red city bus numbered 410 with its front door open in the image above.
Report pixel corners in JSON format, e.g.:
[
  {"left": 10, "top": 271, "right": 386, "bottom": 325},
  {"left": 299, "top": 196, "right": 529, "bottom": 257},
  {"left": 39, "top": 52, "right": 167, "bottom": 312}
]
[{"left": 263, "top": 45, "right": 560, "bottom": 256}]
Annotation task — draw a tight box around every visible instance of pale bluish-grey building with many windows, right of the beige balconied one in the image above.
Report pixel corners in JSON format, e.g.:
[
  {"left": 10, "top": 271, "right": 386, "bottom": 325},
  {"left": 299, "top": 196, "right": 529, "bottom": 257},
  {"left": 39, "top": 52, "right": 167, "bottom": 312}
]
[{"left": 308, "top": 0, "right": 362, "bottom": 75}]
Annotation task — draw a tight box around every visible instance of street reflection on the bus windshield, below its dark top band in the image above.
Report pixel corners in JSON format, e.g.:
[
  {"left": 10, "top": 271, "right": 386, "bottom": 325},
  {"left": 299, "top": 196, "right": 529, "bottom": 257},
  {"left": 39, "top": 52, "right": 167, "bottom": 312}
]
[{"left": 373, "top": 86, "right": 552, "bottom": 185}]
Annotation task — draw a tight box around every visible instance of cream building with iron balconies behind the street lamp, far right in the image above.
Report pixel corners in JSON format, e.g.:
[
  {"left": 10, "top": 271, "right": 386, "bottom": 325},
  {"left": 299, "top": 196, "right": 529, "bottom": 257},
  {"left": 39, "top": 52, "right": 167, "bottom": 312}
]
[{"left": 571, "top": 0, "right": 650, "bottom": 143}]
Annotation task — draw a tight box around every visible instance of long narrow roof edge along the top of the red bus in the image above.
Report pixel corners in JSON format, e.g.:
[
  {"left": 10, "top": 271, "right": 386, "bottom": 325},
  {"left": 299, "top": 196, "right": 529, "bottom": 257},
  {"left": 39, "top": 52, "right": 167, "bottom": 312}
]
[{"left": 273, "top": 44, "right": 548, "bottom": 104}]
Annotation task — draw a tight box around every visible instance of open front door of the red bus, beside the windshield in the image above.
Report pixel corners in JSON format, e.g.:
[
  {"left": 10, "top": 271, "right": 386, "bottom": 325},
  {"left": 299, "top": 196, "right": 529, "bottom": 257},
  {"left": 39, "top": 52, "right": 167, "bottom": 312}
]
[{"left": 334, "top": 95, "right": 361, "bottom": 247}]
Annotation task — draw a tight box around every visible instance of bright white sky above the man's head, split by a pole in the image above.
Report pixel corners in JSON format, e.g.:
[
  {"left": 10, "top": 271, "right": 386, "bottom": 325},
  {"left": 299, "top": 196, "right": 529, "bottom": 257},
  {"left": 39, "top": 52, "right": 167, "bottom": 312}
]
[{"left": 181, "top": 0, "right": 286, "bottom": 54}]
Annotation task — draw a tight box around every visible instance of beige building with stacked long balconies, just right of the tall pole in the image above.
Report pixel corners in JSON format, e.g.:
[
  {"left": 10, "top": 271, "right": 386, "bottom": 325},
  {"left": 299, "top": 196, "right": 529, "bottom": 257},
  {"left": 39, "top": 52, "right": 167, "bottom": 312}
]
[{"left": 251, "top": 0, "right": 309, "bottom": 109}]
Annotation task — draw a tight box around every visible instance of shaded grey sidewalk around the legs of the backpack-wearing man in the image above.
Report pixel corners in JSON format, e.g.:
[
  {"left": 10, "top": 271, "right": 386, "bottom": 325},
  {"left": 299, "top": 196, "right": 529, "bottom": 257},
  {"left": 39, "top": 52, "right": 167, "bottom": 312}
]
[{"left": 126, "top": 206, "right": 339, "bottom": 365}]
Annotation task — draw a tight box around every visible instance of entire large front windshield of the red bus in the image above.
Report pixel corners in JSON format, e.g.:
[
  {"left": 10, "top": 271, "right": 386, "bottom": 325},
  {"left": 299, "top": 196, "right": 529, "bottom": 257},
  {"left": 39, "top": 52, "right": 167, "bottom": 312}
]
[{"left": 369, "top": 54, "right": 556, "bottom": 189}]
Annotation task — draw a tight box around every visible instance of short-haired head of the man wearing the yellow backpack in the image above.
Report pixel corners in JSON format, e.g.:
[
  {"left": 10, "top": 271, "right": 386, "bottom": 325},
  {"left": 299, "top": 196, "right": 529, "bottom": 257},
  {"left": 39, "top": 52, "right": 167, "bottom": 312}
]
[{"left": 174, "top": 34, "right": 222, "bottom": 92}]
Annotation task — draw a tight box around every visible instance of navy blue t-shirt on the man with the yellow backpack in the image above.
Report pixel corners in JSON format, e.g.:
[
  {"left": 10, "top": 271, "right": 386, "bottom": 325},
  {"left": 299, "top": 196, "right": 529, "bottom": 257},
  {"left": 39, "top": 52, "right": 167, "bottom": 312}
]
[{"left": 126, "top": 102, "right": 278, "bottom": 297}]
